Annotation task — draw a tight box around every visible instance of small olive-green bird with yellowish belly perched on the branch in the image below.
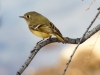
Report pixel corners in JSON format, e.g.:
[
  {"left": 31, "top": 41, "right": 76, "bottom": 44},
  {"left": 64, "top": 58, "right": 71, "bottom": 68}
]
[{"left": 20, "top": 11, "right": 67, "bottom": 43}]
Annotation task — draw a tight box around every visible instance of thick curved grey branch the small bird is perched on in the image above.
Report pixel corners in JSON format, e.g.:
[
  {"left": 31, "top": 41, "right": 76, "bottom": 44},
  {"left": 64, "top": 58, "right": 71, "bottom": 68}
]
[{"left": 16, "top": 24, "right": 100, "bottom": 75}]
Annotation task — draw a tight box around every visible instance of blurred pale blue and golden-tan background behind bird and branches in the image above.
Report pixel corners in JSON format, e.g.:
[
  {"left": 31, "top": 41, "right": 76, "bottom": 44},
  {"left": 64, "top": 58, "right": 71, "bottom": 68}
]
[{"left": 0, "top": 0, "right": 100, "bottom": 75}]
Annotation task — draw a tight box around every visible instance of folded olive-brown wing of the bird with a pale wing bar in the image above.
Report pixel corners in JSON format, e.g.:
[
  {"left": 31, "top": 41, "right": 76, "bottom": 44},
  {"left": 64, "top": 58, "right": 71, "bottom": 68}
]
[{"left": 29, "top": 22, "right": 62, "bottom": 36}]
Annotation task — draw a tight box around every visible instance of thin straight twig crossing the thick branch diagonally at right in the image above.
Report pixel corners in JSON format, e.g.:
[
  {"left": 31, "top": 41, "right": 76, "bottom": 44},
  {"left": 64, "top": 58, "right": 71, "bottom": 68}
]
[{"left": 62, "top": 7, "right": 100, "bottom": 75}]
